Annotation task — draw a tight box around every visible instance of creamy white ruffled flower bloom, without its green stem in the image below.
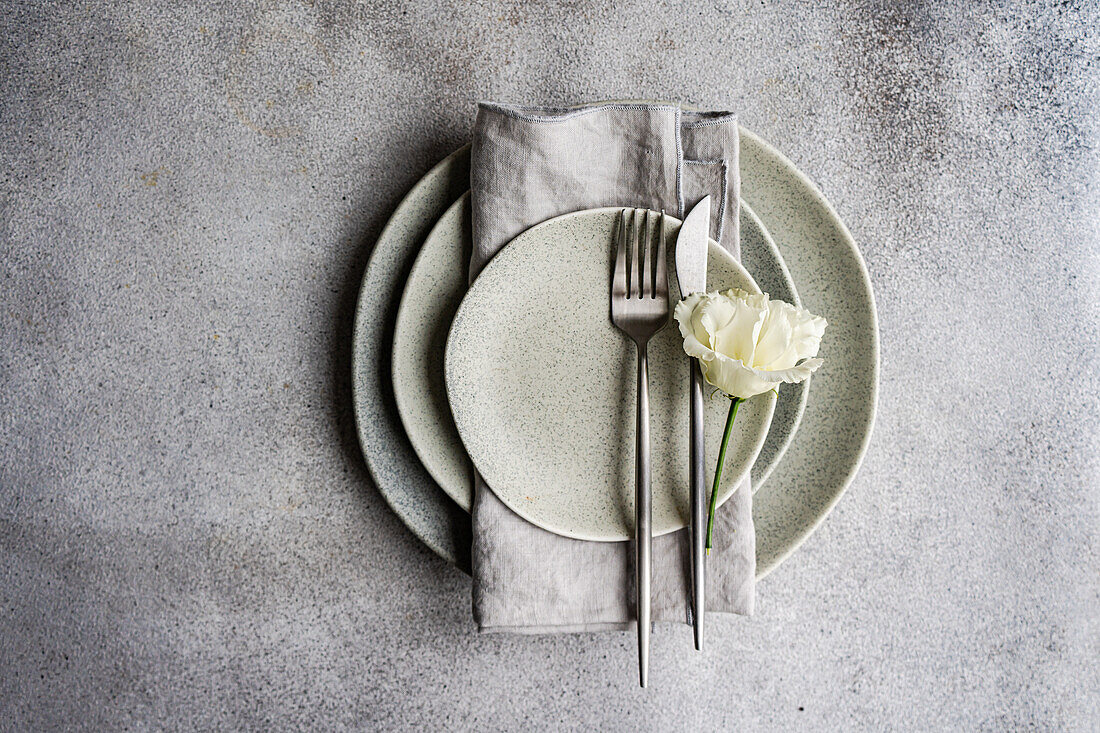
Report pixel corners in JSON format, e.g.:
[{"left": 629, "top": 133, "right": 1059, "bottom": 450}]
[{"left": 675, "top": 289, "right": 826, "bottom": 400}]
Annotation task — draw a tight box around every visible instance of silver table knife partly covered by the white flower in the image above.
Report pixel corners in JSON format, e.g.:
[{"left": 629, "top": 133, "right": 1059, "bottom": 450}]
[{"left": 675, "top": 196, "right": 711, "bottom": 650}]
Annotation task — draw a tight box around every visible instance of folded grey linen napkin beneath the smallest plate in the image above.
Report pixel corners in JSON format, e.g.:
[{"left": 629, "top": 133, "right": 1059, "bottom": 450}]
[{"left": 470, "top": 103, "right": 756, "bottom": 634}]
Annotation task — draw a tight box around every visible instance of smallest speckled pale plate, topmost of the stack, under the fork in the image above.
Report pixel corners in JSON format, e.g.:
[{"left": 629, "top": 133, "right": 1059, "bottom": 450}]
[{"left": 443, "top": 208, "right": 776, "bottom": 541}]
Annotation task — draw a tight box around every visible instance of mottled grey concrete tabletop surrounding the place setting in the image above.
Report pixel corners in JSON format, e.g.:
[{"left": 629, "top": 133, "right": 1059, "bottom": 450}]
[{"left": 0, "top": 0, "right": 1100, "bottom": 730}]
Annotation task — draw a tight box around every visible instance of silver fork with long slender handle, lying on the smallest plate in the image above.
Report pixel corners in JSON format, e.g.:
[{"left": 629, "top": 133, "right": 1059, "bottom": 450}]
[{"left": 612, "top": 209, "right": 669, "bottom": 687}]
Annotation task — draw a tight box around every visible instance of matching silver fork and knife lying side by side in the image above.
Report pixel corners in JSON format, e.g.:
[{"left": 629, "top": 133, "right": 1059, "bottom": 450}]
[{"left": 611, "top": 196, "right": 711, "bottom": 687}]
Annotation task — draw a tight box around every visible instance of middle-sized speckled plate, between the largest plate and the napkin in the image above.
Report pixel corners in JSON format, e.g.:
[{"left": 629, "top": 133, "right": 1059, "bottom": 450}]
[{"left": 392, "top": 194, "right": 809, "bottom": 511}]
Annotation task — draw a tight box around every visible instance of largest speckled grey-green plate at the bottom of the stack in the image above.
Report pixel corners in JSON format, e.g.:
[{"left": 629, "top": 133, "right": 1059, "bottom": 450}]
[{"left": 352, "top": 128, "right": 879, "bottom": 577}]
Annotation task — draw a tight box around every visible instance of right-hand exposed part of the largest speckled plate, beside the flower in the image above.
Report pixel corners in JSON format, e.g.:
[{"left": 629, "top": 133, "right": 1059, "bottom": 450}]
[{"left": 740, "top": 128, "right": 879, "bottom": 576}]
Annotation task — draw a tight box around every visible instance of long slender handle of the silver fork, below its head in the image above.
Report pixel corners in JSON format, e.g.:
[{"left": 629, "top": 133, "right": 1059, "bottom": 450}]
[{"left": 634, "top": 343, "right": 653, "bottom": 687}]
